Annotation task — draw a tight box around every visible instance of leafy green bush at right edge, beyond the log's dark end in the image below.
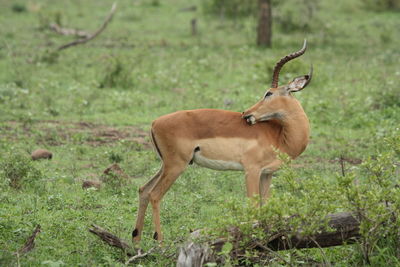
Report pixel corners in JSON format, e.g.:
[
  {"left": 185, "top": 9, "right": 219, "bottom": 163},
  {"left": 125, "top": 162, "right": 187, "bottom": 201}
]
[{"left": 338, "top": 135, "right": 400, "bottom": 266}]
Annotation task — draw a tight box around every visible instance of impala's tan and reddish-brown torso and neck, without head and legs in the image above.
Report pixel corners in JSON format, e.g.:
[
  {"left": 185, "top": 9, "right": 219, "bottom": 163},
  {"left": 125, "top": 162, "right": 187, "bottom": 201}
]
[{"left": 152, "top": 107, "right": 309, "bottom": 168}]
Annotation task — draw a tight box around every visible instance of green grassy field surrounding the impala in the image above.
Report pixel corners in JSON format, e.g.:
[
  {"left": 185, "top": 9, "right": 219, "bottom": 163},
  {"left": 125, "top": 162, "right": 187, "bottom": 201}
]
[{"left": 0, "top": 0, "right": 400, "bottom": 266}]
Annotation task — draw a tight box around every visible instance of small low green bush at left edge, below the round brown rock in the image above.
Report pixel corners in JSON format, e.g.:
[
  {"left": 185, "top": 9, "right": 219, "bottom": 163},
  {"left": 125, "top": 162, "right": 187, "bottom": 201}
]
[{"left": 0, "top": 153, "right": 42, "bottom": 189}]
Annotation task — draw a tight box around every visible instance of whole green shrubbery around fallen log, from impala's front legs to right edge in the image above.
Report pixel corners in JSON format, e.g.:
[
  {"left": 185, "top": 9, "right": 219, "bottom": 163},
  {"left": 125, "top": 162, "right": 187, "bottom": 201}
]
[{"left": 211, "top": 133, "right": 400, "bottom": 266}]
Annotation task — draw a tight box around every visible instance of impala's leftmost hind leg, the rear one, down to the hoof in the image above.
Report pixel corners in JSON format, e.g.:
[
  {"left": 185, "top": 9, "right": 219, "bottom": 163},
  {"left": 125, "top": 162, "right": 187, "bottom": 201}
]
[{"left": 132, "top": 167, "right": 163, "bottom": 242}]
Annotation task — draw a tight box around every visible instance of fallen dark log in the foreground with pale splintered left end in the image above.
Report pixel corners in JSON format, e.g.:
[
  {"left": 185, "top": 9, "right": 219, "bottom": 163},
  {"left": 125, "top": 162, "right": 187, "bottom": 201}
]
[{"left": 177, "top": 212, "right": 360, "bottom": 267}]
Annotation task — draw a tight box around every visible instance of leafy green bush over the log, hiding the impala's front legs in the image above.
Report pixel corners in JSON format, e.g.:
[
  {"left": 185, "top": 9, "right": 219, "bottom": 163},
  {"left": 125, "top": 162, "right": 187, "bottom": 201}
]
[{"left": 211, "top": 154, "right": 341, "bottom": 264}]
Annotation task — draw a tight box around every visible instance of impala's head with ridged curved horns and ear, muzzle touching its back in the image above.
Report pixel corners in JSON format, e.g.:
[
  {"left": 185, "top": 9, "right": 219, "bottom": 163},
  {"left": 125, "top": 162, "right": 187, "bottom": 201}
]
[{"left": 242, "top": 40, "right": 313, "bottom": 125}]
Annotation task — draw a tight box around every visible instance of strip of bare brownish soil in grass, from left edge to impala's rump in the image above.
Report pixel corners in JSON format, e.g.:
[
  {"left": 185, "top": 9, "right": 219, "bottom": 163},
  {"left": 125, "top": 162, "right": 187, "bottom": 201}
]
[{"left": 0, "top": 120, "right": 151, "bottom": 149}]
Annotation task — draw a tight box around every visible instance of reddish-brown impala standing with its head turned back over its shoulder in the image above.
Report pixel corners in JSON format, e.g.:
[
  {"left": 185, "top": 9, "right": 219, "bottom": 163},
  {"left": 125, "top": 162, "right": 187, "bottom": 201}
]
[{"left": 132, "top": 41, "right": 312, "bottom": 242}]
